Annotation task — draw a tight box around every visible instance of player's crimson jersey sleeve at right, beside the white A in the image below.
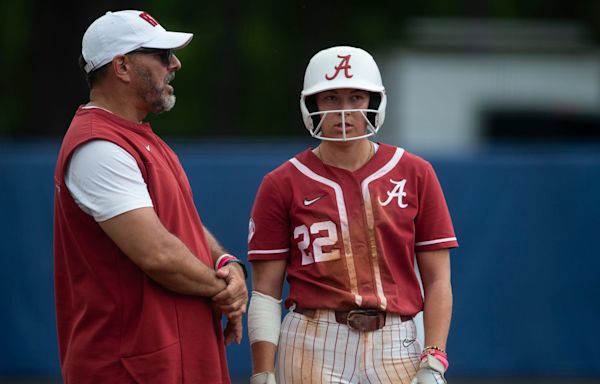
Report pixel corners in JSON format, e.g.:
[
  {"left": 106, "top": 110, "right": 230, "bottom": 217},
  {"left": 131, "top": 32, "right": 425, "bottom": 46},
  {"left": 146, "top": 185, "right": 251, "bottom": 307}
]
[{"left": 415, "top": 163, "right": 458, "bottom": 252}]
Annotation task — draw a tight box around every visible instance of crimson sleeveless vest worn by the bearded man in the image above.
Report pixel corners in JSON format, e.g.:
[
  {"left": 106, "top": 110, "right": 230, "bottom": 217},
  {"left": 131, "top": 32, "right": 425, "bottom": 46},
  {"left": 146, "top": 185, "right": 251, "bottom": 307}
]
[{"left": 54, "top": 108, "right": 230, "bottom": 384}]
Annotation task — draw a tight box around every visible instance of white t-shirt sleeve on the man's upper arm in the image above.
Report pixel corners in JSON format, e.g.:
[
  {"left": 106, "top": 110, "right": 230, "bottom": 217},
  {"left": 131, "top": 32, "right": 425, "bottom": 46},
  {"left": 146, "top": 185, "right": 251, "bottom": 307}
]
[{"left": 65, "top": 140, "right": 153, "bottom": 222}]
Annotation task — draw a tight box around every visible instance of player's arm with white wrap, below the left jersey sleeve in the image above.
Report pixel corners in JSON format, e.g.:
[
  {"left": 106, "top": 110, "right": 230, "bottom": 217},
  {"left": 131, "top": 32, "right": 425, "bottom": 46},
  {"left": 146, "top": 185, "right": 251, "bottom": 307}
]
[{"left": 248, "top": 259, "right": 287, "bottom": 375}]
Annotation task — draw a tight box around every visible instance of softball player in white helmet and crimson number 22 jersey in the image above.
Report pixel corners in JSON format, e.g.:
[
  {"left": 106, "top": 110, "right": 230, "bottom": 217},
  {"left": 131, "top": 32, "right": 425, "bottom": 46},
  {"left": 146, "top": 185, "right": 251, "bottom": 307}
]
[{"left": 248, "top": 46, "right": 458, "bottom": 384}]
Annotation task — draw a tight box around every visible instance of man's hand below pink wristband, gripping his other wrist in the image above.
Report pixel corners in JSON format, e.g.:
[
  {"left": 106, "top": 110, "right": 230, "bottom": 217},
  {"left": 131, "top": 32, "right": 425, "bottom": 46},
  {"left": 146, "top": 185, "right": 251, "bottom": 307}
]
[{"left": 212, "top": 263, "right": 248, "bottom": 319}]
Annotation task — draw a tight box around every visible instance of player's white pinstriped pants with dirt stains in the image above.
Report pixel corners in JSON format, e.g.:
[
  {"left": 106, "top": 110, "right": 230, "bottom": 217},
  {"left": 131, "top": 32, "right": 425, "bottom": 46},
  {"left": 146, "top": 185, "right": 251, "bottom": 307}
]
[{"left": 275, "top": 310, "right": 421, "bottom": 384}]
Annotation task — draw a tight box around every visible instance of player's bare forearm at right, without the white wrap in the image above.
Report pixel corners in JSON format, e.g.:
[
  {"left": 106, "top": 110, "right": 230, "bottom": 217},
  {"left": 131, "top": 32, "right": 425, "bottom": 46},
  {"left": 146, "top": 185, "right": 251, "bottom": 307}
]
[{"left": 417, "top": 249, "right": 452, "bottom": 349}]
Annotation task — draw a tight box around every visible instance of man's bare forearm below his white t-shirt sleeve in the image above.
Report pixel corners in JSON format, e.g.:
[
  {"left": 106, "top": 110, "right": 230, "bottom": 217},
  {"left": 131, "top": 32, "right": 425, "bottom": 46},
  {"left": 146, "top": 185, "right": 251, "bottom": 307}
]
[{"left": 98, "top": 208, "right": 226, "bottom": 297}]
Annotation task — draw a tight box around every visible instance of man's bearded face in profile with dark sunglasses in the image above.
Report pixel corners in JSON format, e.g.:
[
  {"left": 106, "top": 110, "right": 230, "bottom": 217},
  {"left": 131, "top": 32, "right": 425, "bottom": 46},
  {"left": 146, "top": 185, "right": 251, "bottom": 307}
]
[{"left": 129, "top": 50, "right": 181, "bottom": 114}]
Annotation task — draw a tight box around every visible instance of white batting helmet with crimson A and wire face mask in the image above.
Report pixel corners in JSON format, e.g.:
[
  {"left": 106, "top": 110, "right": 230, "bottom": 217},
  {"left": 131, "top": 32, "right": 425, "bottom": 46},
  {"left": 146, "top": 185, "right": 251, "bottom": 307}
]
[{"left": 300, "top": 46, "right": 387, "bottom": 141}]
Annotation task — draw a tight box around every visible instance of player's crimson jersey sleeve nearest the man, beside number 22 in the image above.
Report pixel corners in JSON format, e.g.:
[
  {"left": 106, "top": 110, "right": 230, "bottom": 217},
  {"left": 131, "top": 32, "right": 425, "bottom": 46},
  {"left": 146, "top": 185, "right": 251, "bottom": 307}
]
[{"left": 248, "top": 175, "right": 290, "bottom": 261}]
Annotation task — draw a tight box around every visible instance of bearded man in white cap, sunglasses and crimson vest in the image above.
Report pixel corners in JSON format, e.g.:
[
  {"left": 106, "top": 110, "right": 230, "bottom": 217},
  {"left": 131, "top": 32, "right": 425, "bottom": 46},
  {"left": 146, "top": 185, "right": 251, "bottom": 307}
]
[{"left": 54, "top": 11, "right": 247, "bottom": 384}]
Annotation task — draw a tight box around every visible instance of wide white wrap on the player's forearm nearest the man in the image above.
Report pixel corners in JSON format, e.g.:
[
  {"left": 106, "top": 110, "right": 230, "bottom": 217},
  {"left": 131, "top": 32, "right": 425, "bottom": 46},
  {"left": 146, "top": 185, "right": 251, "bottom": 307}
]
[{"left": 248, "top": 291, "right": 281, "bottom": 346}]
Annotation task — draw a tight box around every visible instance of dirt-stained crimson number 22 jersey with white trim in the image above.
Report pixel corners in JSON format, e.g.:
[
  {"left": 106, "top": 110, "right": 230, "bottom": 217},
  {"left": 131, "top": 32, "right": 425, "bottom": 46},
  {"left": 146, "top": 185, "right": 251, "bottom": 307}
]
[{"left": 248, "top": 144, "right": 458, "bottom": 315}]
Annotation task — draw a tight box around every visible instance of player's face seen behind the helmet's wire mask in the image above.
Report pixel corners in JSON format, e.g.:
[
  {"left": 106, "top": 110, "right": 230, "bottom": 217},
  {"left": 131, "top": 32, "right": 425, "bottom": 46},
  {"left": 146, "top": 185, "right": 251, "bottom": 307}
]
[{"left": 316, "top": 89, "right": 369, "bottom": 138}]
